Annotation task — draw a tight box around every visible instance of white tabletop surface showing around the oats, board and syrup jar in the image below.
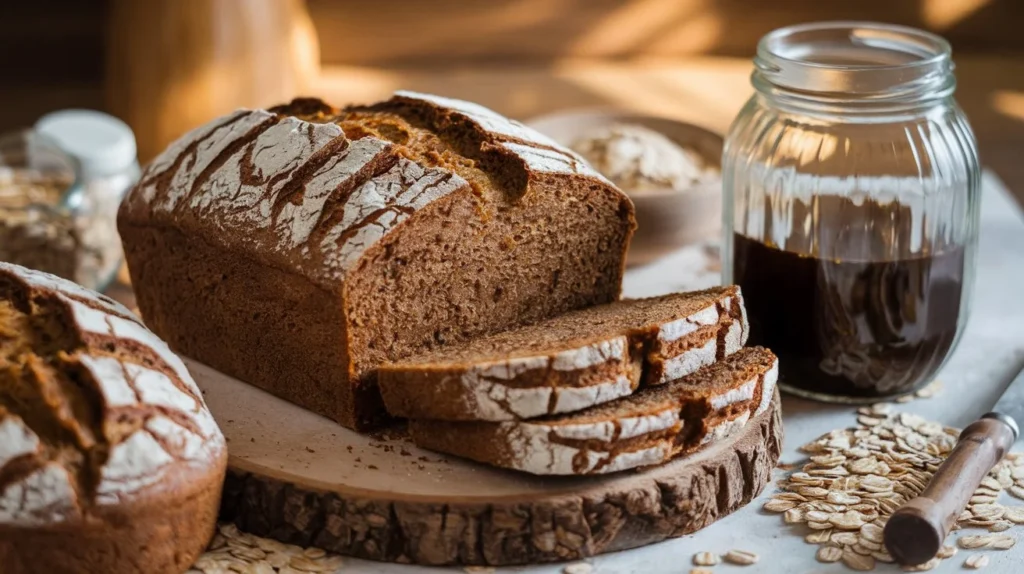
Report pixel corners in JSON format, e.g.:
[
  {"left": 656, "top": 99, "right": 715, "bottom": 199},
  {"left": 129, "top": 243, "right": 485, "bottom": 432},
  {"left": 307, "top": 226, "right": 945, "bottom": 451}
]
[{"left": 343, "top": 175, "right": 1024, "bottom": 574}]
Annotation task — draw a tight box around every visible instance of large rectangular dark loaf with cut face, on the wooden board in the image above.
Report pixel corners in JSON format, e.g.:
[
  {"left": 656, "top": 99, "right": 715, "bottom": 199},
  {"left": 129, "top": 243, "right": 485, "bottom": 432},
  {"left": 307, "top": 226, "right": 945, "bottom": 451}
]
[{"left": 118, "top": 93, "right": 635, "bottom": 428}]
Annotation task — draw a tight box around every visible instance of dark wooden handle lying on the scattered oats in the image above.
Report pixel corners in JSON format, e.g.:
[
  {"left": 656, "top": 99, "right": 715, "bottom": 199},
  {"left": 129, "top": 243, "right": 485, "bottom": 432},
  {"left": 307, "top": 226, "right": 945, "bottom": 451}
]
[{"left": 885, "top": 413, "right": 1017, "bottom": 566}]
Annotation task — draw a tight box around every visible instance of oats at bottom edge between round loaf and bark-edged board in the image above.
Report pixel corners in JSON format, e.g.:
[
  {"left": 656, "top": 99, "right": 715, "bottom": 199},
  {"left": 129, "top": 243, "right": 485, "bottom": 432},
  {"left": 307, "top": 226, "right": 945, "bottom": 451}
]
[{"left": 186, "top": 524, "right": 342, "bottom": 574}]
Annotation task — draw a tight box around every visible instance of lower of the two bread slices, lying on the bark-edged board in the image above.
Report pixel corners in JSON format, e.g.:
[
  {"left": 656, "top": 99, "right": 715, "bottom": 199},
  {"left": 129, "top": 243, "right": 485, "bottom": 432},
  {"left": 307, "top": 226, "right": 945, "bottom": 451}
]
[{"left": 409, "top": 347, "right": 778, "bottom": 475}]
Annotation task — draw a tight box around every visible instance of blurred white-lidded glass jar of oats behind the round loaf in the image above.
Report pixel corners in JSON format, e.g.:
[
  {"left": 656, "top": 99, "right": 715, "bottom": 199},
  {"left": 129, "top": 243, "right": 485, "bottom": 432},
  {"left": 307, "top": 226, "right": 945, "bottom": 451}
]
[{"left": 0, "top": 111, "right": 139, "bottom": 291}]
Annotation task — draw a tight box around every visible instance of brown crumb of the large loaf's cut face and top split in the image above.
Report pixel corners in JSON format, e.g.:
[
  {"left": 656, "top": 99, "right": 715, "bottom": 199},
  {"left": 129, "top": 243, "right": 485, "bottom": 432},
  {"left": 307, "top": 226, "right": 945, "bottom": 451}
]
[{"left": 332, "top": 102, "right": 626, "bottom": 371}]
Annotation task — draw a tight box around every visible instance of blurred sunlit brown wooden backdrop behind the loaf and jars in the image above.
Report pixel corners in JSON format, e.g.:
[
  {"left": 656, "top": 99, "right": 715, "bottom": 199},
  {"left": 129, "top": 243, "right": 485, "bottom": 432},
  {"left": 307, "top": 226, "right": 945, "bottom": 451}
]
[{"left": 6, "top": 0, "right": 1024, "bottom": 200}]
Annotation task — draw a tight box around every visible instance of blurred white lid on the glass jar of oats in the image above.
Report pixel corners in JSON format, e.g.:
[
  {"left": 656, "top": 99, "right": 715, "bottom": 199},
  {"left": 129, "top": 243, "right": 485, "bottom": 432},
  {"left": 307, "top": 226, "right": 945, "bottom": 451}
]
[{"left": 36, "top": 109, "right": 137, "bottom": 179}]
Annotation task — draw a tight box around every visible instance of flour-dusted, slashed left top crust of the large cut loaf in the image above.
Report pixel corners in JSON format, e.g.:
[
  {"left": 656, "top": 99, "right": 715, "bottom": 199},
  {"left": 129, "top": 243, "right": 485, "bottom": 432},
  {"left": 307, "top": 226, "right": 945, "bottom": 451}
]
[{"left": 123, "top": 111, "right": 468, "bottom": 283}]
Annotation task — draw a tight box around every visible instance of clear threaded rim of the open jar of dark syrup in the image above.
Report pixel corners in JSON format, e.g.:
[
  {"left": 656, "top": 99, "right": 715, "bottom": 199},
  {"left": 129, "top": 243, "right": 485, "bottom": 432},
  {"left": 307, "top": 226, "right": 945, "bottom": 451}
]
[{"left": 755, "top": 20, "right": 955, "bottom": 98}]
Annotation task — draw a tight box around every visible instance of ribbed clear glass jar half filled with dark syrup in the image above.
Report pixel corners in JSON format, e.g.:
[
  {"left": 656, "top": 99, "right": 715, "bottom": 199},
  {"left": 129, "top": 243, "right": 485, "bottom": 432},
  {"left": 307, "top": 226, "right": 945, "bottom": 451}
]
[{"left": 722, "top": 23, "right": 980, "bottom": 402}]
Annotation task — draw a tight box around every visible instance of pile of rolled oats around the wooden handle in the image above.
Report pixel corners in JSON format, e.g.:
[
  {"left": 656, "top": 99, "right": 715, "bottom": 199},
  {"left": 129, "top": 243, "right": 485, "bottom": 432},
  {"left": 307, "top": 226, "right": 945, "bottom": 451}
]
[{"left": 764, "top": 403, "right": 1024, "bottom": 572}]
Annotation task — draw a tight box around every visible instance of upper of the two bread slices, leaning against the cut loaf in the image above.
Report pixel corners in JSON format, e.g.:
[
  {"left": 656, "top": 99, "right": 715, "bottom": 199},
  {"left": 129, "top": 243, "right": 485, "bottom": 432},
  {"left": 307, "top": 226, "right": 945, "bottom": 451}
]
[{"left": 379, "top": 286, "right": 748, "bottom": 421}]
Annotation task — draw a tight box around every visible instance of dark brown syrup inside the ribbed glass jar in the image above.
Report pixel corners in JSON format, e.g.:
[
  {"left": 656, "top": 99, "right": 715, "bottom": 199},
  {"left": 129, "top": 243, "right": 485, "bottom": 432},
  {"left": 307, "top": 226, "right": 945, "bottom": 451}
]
[{"left": 732, "top": 196, "right": 965, "bottom": 399}]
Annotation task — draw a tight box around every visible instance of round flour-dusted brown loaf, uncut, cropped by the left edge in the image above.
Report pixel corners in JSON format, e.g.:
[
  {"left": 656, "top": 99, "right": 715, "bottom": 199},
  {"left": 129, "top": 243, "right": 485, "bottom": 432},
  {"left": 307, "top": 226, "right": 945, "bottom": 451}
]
[{"left": 0, "top": 263, "right": 227, "bottom": 574}]
